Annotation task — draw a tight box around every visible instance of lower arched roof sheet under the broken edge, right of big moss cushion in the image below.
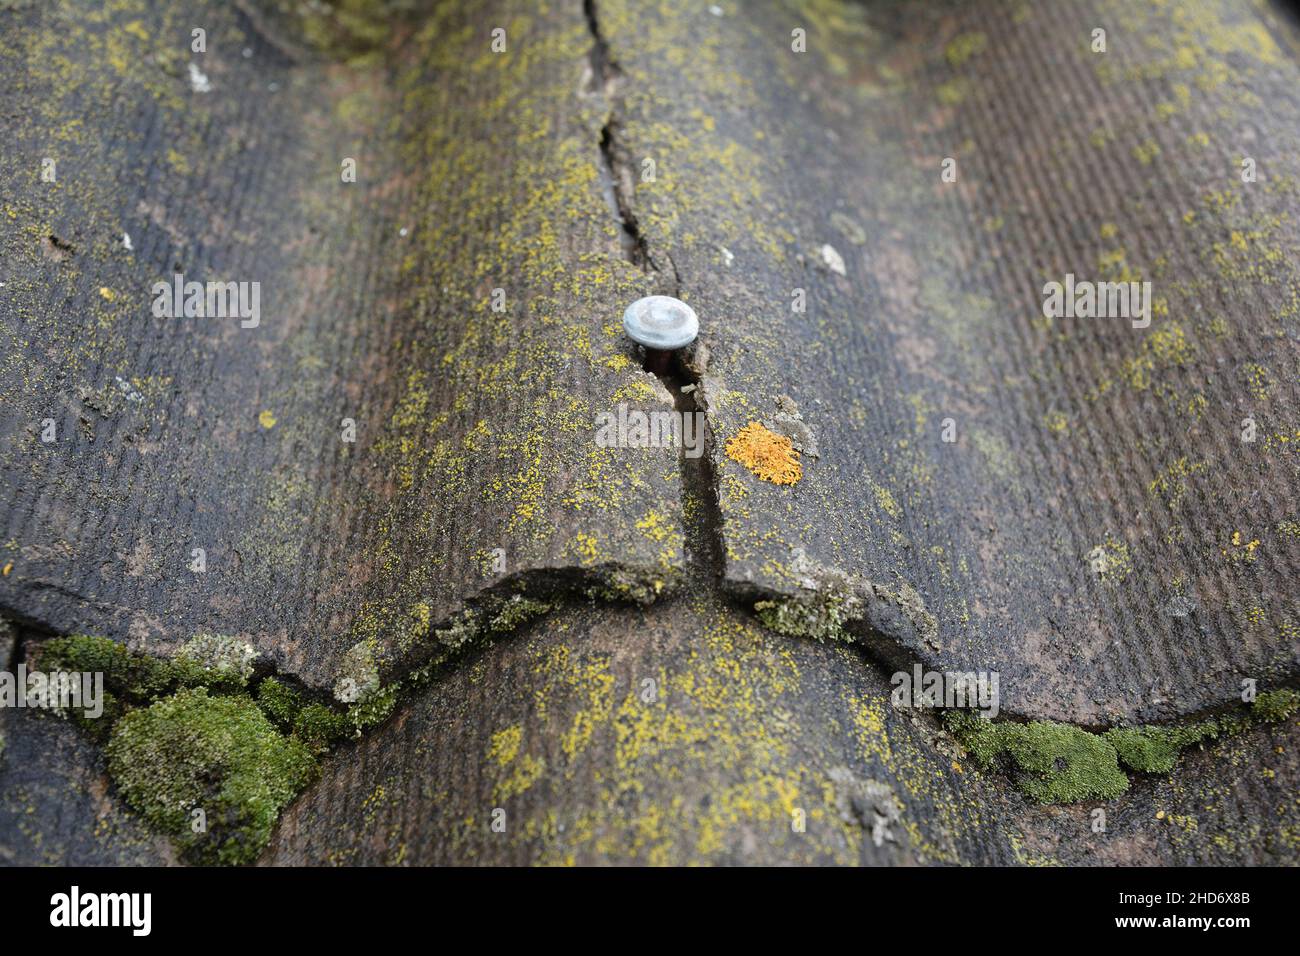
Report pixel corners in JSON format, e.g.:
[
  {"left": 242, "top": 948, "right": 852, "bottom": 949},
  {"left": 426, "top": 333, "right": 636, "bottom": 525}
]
[{"left": 263, "top": 597, "right": 1300, "bottom": 865}]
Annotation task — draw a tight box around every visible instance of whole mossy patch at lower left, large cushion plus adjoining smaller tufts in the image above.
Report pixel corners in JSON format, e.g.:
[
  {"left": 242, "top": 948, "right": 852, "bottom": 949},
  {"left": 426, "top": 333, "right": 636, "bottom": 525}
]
[{"left": 38, "top": 635, "right": 361, "bottom": 864}]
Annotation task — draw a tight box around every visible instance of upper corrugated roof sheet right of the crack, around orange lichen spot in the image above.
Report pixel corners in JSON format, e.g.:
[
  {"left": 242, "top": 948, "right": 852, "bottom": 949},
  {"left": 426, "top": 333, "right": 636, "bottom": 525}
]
[{"left": 599, "top": 1, "right": 1300, "bottom": 724}]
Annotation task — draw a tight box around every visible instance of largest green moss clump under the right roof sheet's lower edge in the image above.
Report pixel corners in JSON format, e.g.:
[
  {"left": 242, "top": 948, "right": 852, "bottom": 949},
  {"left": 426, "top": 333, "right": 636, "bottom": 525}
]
[{"left": 946, "top": 711, "right": 1128, "bottom": 804}]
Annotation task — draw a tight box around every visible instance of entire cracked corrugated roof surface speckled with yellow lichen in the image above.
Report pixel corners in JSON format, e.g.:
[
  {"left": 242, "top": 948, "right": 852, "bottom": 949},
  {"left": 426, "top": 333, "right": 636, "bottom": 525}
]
[{"left": 0, "top": 0, "right": 1300, "bottom": 864}]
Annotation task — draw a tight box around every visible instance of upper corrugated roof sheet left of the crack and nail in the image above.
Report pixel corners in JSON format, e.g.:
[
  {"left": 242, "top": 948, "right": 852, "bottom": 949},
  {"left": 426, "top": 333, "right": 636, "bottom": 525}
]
[{"left": 0, "top": 0, "right": 681, "bottom": 685}]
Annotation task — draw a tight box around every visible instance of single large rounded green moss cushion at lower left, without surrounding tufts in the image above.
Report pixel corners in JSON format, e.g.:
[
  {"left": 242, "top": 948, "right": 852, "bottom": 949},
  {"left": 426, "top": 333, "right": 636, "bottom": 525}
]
[{"left": 107, "top": 688, "right": 316, "bottom": 864}]
